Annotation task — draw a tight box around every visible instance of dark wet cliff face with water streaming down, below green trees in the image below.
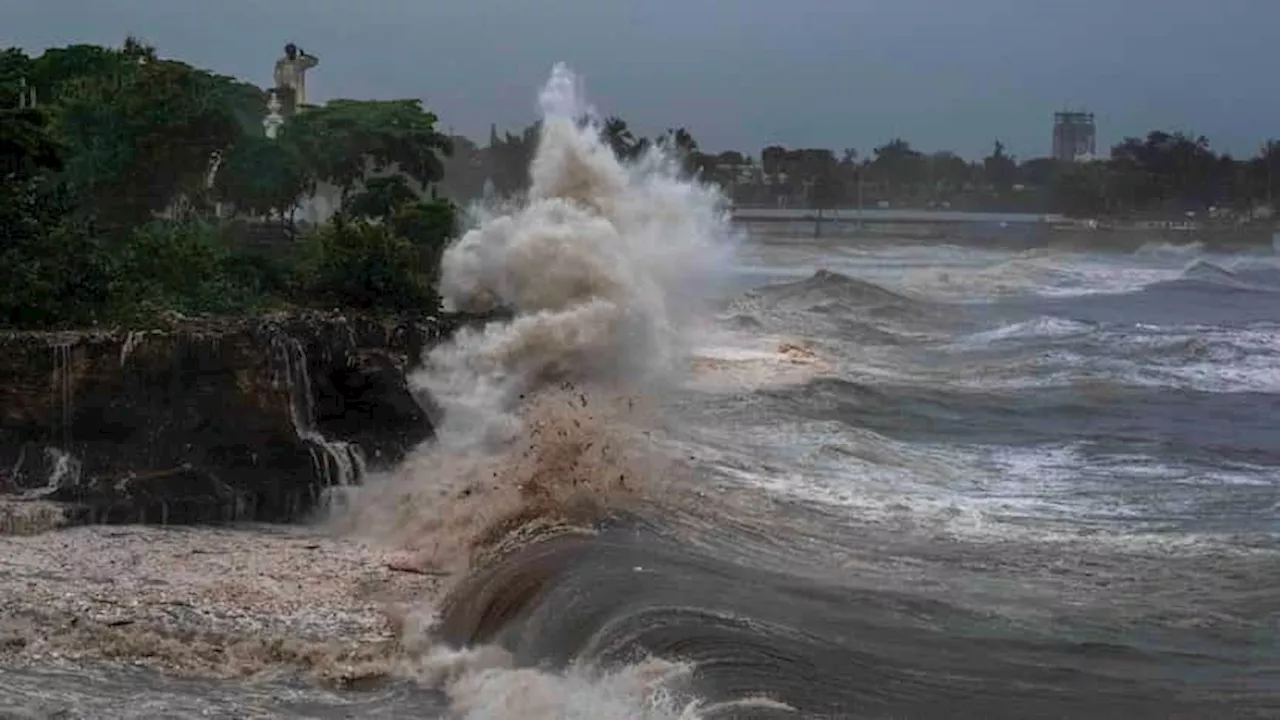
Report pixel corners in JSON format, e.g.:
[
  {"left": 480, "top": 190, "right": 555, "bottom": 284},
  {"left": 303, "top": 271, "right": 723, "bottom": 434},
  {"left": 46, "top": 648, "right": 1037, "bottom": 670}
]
[{"left": 0, "top": 313, "right": 454, "bottom": 523}]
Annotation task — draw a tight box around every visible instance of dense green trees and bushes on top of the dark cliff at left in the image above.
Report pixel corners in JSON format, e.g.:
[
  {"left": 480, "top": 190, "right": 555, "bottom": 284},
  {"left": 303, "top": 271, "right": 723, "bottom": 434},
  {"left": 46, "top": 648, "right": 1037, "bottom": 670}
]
[{"left": 0, "top": 40, "right": 456, "bottom": 327}]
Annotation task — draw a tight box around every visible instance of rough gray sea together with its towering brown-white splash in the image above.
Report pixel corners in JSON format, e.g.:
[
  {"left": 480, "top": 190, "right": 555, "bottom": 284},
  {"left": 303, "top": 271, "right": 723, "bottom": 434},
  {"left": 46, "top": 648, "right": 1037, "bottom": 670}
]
[{"left": 0, "top": 64, "right": 1280, "bottom": 719}]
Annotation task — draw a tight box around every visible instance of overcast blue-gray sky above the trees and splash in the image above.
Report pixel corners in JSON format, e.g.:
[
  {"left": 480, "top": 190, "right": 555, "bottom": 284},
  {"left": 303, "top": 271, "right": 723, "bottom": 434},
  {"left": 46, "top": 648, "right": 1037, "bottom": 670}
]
[{"left": 0, "top": 0, "right": 1280, "bottom": 158}]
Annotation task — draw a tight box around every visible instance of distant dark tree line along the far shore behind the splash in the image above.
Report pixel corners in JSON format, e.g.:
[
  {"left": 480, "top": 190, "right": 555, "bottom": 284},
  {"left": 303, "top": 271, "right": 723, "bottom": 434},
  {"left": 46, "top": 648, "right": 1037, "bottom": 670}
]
[{"left": 444, "top": 117, "right": 1280, "bottom": 218}]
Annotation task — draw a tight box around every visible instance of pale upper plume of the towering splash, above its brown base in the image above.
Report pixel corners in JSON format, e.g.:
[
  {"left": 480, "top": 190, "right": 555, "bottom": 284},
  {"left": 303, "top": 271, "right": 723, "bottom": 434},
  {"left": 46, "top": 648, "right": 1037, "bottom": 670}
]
[{"left": 415, "top": 58, "right": 730, "bottom": 447}]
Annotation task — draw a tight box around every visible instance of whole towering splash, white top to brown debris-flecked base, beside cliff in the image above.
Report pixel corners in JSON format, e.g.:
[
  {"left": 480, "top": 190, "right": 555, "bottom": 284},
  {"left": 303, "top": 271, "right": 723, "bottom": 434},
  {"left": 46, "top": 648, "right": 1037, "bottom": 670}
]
[{"left": 347, "top": 60, "right": 732, "bottom": 556}]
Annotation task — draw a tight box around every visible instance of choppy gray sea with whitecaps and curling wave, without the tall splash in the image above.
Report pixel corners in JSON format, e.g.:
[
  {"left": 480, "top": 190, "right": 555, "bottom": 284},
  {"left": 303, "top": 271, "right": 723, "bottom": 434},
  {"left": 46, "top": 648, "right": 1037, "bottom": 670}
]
[{"left": 0, "top": 240, "right": 1280, "bottom": 719}]
